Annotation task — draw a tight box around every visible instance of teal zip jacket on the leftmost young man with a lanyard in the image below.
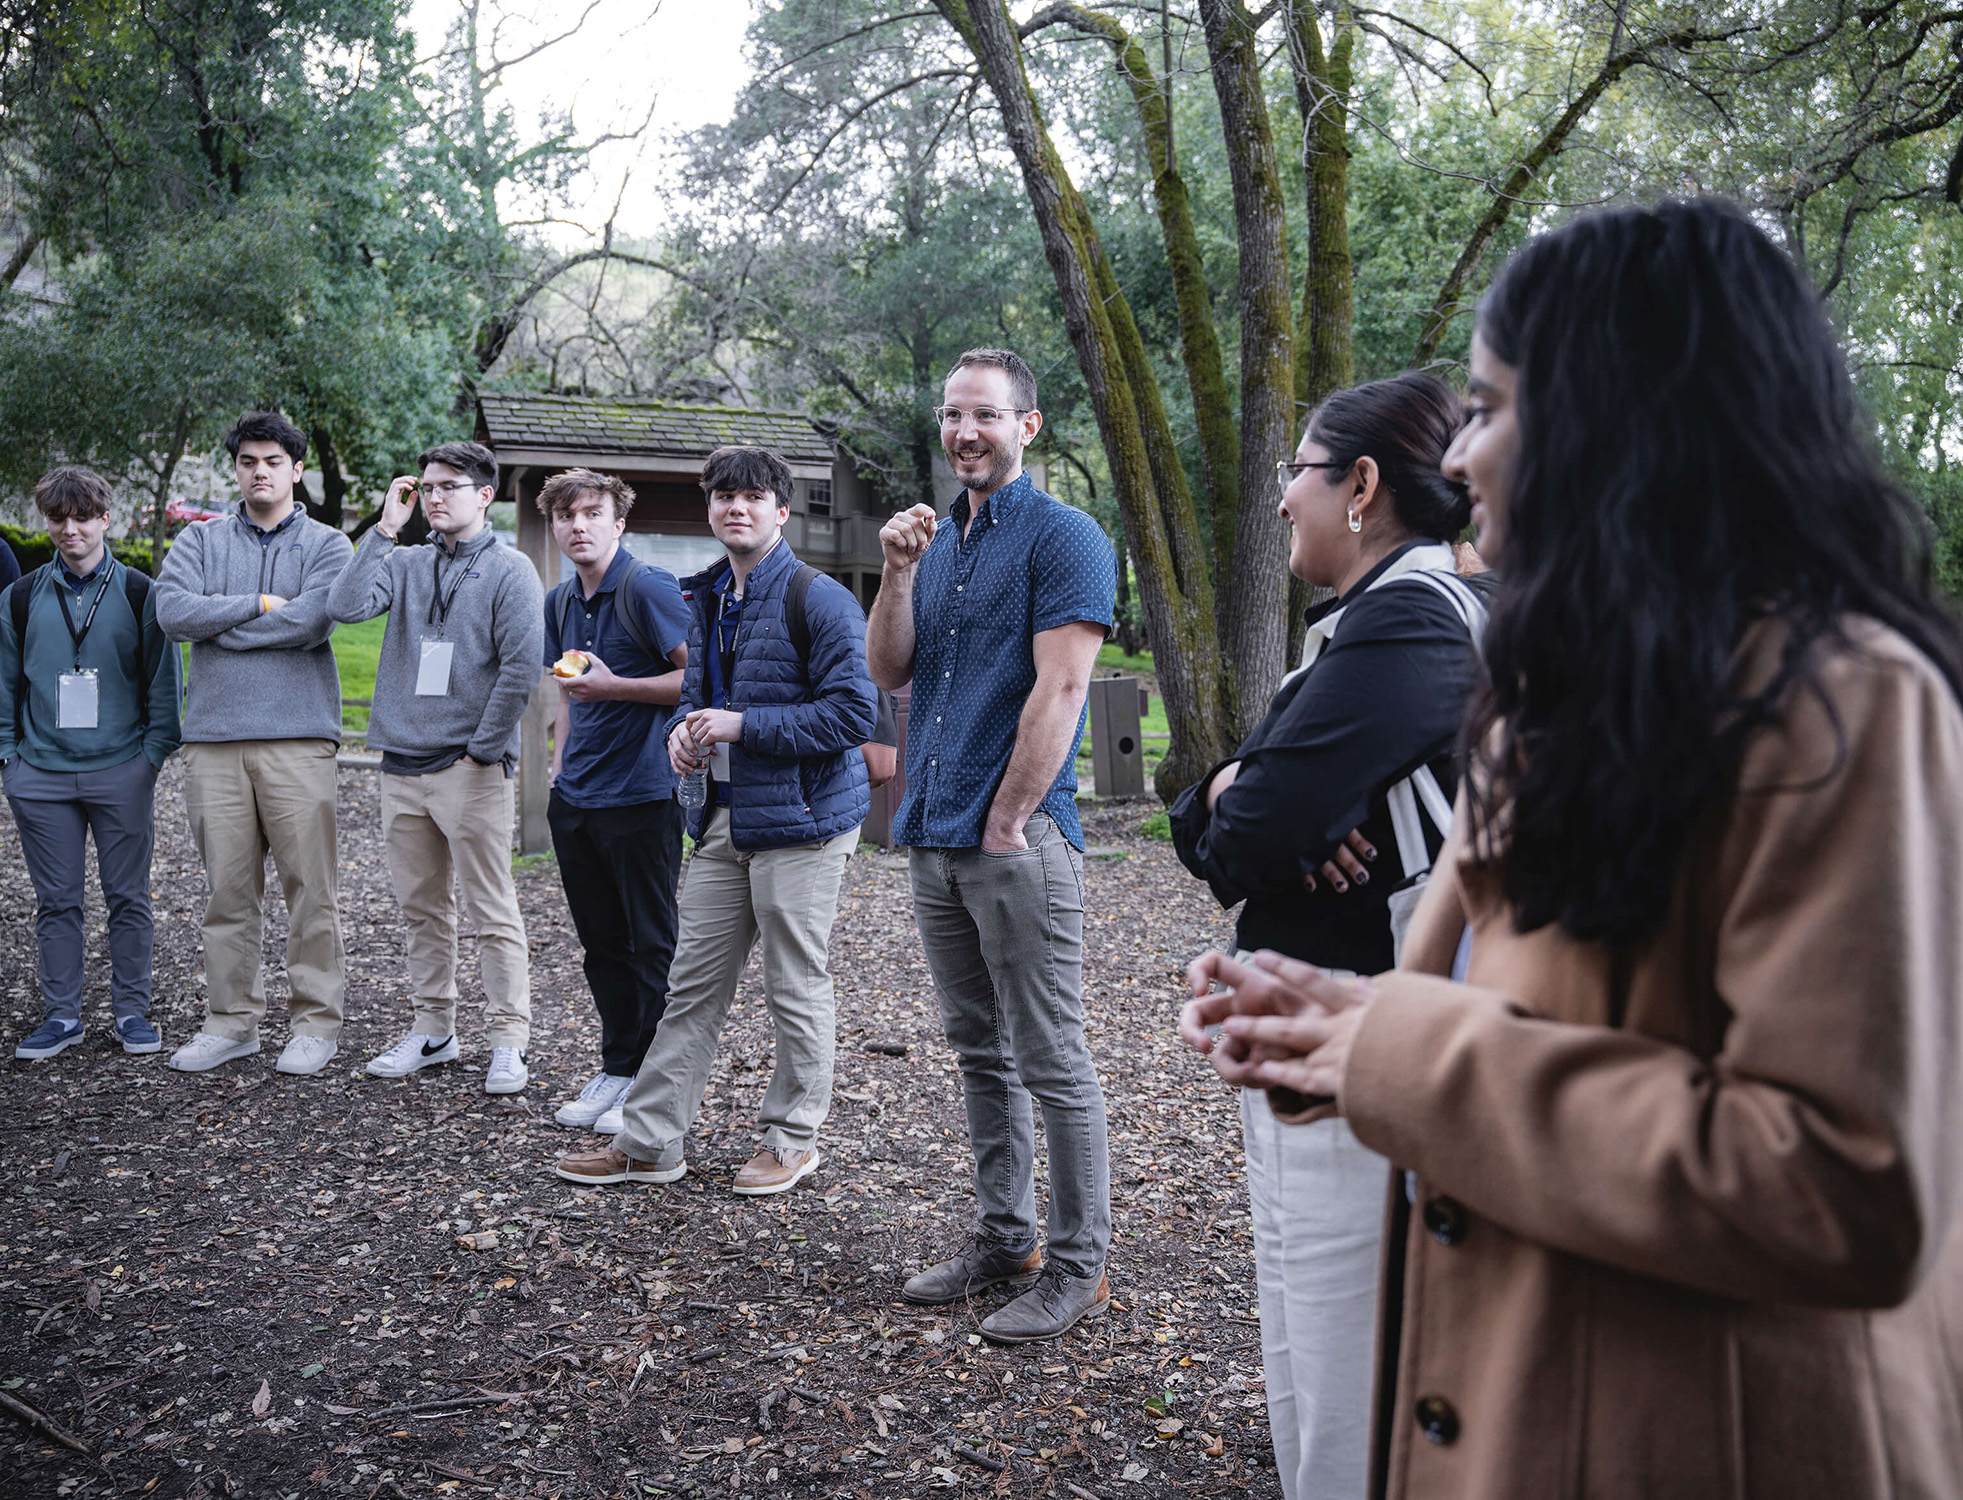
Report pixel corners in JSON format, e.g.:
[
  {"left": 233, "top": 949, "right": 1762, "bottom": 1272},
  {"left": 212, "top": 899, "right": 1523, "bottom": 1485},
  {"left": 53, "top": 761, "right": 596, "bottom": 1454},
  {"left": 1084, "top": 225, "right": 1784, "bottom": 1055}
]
[{"left": 0, "top": 558, "right": 183, "bottom": 772}]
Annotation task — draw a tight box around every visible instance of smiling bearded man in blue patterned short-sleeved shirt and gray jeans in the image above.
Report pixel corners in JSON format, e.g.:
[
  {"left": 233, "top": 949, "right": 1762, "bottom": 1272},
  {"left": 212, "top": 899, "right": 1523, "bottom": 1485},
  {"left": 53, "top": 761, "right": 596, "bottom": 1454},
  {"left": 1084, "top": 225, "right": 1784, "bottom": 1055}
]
[{"left": 866, "top": 349, "right": 1117, "bottom": 1343}]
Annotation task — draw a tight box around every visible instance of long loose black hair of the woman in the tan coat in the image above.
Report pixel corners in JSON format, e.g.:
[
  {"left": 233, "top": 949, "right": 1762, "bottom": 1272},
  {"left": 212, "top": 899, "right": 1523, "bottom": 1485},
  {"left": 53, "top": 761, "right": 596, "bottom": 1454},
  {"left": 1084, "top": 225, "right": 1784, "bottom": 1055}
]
[{"left": 1466, "top": 200, "right": 1963, "bottom": 944}]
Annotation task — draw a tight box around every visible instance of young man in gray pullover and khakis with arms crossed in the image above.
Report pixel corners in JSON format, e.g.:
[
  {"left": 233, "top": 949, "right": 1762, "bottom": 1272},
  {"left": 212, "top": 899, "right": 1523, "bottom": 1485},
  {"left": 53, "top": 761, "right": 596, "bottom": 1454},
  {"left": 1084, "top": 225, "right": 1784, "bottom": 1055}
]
[{"left": 157, "top": 412, "right": 353, "bottom": 1074}]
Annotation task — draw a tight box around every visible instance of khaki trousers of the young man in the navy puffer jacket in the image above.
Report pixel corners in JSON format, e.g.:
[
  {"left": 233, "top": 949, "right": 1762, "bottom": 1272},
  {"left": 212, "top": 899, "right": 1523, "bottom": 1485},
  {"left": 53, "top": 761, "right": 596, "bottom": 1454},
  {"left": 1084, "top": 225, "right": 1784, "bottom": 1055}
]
[{"left": 614, "top": 809, "right": 858, "bottom": 1166}]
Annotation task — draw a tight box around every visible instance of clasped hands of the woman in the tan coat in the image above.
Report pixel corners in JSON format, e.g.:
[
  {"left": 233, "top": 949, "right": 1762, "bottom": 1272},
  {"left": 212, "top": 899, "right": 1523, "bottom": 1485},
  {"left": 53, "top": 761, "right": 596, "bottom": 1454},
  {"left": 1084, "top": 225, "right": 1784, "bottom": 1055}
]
[{"left": 1180, "top": 948, "right": 1376, "bottom": 1098}]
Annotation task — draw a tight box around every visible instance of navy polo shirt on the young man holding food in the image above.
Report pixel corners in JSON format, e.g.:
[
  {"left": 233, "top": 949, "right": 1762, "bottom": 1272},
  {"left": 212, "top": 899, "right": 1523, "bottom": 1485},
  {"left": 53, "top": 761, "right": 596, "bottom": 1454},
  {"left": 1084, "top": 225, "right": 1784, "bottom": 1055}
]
[{"left": 546, "top": 548, "right": 689, "bottom": 807}]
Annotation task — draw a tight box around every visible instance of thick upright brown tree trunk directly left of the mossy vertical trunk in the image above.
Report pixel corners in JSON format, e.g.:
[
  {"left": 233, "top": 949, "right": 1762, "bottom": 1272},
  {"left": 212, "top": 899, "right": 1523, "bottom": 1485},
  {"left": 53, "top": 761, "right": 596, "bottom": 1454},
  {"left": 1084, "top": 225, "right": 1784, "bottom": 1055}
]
[{"left": 1199, "top": 0, "right": 1296, "bottom": 738}]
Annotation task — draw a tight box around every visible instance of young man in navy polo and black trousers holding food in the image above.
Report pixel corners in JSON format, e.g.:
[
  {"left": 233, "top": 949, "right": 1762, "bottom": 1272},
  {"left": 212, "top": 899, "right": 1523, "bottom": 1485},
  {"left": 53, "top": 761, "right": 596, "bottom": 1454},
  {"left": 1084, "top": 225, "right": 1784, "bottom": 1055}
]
[{"left": 538, "top": 469, "right": 689, "bottom": 1129}]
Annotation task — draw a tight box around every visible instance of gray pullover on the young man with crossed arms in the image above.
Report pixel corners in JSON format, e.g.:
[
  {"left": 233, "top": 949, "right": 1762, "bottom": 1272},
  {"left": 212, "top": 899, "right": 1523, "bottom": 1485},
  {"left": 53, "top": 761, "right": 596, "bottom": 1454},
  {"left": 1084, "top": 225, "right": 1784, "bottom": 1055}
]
[{"left": 157, "top": 507, "right": 353, "bottom": 744}]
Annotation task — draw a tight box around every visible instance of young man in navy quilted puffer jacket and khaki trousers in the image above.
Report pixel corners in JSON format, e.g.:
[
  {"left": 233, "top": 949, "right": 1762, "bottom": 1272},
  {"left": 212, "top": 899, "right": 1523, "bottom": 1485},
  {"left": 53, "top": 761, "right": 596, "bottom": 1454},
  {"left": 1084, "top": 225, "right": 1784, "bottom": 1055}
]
[{"left": 557, "top": 448, "right": 877, "bottom": 1198}]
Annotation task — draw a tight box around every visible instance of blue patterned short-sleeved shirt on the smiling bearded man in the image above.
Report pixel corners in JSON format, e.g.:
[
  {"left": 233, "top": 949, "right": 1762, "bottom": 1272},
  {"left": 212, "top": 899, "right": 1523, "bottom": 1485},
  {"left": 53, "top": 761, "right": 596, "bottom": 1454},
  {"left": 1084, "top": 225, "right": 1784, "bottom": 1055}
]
[{"left": 893, "top": 473, "right": 1117, "bottom": 848}]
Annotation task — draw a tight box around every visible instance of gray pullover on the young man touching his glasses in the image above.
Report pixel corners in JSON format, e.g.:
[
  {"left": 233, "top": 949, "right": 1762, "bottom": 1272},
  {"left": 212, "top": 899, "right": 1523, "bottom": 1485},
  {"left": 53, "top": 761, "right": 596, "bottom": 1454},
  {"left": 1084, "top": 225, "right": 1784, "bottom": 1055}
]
[{"left": 328, "top": 526, "right": 546, "bottom": 766}]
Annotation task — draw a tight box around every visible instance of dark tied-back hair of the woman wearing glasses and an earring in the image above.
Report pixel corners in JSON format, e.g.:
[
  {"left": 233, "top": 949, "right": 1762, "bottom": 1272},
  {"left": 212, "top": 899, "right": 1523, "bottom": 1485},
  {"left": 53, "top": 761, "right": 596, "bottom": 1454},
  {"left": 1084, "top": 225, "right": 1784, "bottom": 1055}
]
[{"left": 1309, "top": 373, "right": 1472, "bottom": 542}]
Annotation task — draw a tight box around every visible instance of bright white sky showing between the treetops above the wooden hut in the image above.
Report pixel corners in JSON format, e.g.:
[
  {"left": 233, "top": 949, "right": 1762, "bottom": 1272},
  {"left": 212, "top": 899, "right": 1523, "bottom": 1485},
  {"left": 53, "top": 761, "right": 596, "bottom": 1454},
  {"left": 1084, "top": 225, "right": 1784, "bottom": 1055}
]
[{"left": 410, "top": 0, "right": 754, "bottom": 238}]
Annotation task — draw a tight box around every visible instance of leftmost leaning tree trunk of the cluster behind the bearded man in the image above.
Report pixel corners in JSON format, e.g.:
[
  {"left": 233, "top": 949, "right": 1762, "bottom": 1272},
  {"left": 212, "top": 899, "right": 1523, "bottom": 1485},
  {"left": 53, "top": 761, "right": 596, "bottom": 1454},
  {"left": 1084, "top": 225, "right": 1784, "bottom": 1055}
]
[{"left": 934, "top": 0, "right": 1227, "bottom": 799}]
